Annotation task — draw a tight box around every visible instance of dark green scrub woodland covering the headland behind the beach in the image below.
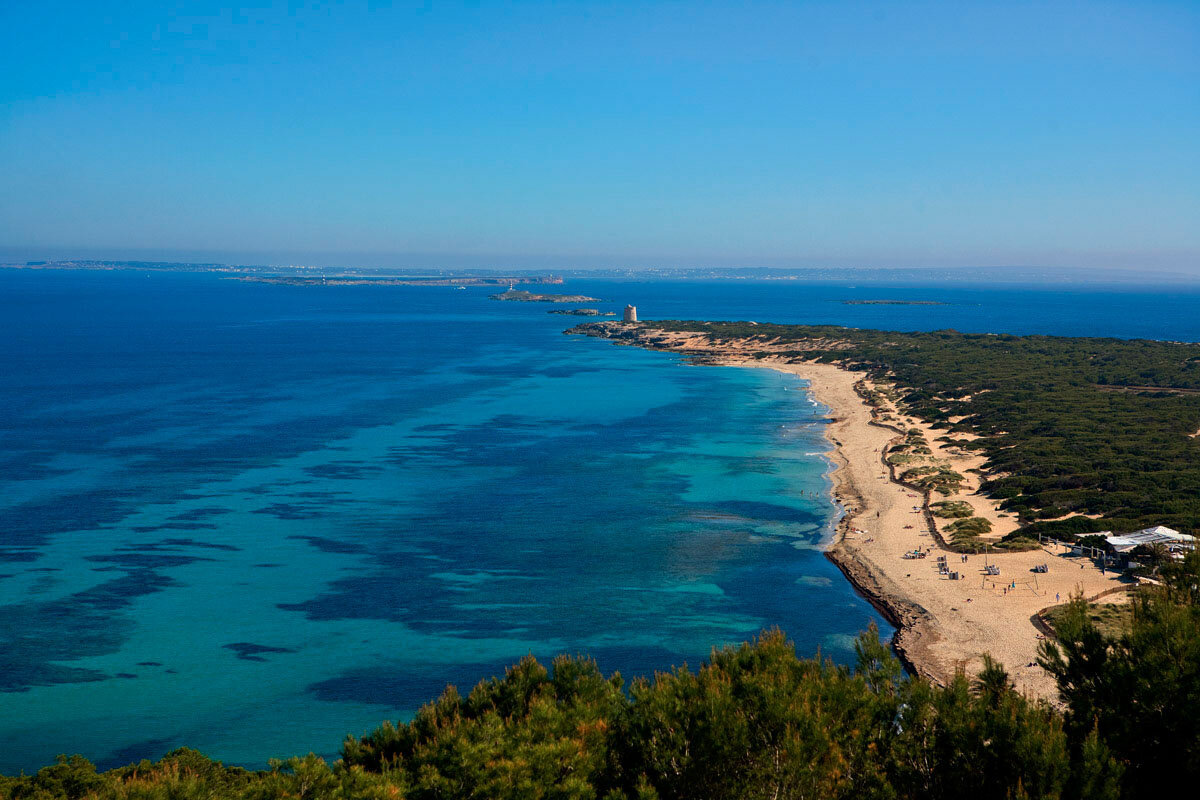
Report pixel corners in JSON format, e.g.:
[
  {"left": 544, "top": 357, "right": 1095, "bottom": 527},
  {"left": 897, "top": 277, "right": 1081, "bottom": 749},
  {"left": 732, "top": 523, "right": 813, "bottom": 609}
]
[{"left": 629, "top": 321, "right": 1200, "bottom": 540}]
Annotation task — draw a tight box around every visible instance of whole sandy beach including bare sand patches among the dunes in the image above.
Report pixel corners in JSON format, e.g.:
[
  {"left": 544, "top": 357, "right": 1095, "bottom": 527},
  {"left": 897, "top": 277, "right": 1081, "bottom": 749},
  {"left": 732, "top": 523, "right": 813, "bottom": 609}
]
[{"left": 585, "top": 332, "right": 1126, "bottom": 700}]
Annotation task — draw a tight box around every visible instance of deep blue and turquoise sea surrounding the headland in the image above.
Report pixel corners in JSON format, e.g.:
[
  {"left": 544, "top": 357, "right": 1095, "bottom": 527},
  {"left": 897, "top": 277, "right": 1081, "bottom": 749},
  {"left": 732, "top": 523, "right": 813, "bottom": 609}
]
[{"left": 0, "top": 270, "right": 1200, "bottom": 774}]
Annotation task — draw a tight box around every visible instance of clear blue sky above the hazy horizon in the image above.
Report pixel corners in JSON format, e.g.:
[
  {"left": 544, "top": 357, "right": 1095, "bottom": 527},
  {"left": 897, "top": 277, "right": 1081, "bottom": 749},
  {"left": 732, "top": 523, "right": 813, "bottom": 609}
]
[{"left": 0, "top": 0, "right": 1200, "bottom": 273}]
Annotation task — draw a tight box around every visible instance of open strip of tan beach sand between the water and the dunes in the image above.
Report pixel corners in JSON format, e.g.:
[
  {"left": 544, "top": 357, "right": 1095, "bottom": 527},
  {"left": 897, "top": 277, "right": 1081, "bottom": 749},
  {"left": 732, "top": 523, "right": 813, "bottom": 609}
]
[{"left": 708, "top": 356, "right": 1098, "bottom": 702}]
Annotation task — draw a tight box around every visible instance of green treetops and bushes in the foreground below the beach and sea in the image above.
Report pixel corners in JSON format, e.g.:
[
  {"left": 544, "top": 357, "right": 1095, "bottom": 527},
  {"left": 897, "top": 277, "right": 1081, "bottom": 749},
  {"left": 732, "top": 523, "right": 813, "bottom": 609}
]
[{"left": 0, "top": 554, "right": 1200, "bottom": 800}]
